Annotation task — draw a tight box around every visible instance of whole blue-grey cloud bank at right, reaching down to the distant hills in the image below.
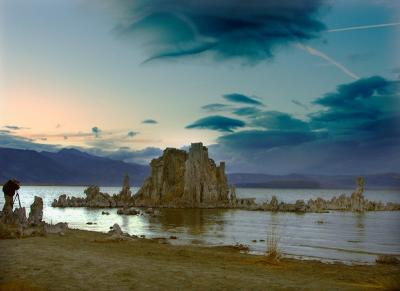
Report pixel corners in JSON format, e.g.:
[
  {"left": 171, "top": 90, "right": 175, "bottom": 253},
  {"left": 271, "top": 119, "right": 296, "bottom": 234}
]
[{"left": 210, "top": 76, "right": 400, "bottom": 175}]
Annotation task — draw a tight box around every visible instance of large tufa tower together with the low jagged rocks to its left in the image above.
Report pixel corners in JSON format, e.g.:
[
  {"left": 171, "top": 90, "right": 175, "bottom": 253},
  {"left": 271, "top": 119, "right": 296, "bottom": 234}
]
[{"left": 52, "top": 143, "right": 237, "bottom": 208}]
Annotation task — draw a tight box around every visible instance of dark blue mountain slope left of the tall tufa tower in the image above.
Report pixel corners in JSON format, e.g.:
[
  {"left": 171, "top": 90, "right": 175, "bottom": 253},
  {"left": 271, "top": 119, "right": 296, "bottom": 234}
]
[{"left": 0, "top": 148, "right": 150, "bottom": 186}]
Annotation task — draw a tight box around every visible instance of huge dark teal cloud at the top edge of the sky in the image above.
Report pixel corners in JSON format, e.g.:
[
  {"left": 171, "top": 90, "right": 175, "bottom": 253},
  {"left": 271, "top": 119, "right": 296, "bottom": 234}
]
[{"left": 114, "top": 0, "right": 325, "bottom": 63}]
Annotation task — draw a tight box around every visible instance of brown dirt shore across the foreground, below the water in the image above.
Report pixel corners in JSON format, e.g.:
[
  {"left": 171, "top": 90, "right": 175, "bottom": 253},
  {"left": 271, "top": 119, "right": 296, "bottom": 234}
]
[{"left": 0, "top": 230, "right": 400, "bottom": 290}]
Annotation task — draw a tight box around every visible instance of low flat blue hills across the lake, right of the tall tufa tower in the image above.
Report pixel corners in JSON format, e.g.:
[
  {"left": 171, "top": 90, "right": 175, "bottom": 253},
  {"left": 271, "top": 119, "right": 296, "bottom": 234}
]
[{"left": 228, "top": 173, "right": 400, "bottom": 189}]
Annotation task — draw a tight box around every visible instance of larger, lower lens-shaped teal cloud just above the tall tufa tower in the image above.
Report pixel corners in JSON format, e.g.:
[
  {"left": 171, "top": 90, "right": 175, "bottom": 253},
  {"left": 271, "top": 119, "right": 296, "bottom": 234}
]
[{"left": 186, "top": 115, "right": 246, "bottom": 132}]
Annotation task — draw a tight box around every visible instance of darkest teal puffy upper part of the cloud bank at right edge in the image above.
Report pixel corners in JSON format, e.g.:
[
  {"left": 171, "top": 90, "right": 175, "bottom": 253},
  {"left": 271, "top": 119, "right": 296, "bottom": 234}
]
[{"left": 310, "top": 76, "right": 400, "bottom": 139}]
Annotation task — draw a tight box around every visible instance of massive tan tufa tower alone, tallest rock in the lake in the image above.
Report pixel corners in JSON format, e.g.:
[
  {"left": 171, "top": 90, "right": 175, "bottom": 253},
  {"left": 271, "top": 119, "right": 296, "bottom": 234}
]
[{"left": 134, "top": 143, "right": 230, "bottom": 207}]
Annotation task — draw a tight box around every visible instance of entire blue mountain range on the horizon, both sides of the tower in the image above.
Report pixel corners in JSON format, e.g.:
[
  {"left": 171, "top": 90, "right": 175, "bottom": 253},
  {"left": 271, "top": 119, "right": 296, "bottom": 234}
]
[{"left": 0, "top": 148, "right": 400, "bottom": 189}]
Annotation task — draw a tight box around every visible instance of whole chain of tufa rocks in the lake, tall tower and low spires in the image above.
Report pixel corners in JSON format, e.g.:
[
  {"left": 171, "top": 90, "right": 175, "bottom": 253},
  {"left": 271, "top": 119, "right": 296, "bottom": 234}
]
[{"left": 52, "top": 143, "right": 400, "bottom": 214}]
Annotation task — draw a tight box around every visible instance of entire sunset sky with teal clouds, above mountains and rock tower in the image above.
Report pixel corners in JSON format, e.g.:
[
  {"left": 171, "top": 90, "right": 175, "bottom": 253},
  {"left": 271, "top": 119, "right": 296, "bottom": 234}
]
[{"left": 0, "top": 0, "right": 400, "bottom": 174}]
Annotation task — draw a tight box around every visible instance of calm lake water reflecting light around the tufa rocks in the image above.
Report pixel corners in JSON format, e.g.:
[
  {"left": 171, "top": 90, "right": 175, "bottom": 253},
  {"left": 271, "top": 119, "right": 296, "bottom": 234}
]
[{"left": 0, "top": 186, "right": 400, "bottom": 262}]
